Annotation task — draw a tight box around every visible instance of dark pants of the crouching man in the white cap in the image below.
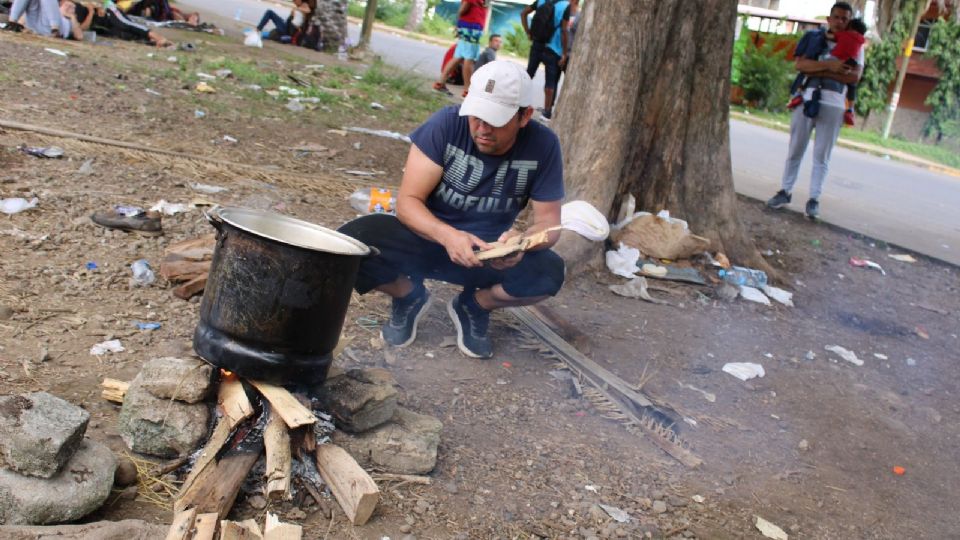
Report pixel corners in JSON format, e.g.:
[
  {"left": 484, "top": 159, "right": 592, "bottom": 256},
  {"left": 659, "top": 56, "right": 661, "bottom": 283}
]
[{"left": 339, "top": 214, "right": 563, "bottom": 298}]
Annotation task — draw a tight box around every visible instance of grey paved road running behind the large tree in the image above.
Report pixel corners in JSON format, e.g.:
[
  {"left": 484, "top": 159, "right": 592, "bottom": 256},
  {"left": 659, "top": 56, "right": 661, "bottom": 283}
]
[{"left": 179, "top": 0, "right": 960, "bottom": 265}]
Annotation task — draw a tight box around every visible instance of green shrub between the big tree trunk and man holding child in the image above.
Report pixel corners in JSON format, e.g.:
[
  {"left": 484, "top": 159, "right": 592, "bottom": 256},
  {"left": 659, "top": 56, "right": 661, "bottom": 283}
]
[{"left": 740, "top": 42, "right": 794, "bottom": 110}]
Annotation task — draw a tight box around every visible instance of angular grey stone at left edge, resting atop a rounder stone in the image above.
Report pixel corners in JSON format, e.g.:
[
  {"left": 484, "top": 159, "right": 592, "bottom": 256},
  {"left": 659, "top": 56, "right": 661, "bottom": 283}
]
[{"left": 0, "top": 392, "right": 90, "bottom": 478}]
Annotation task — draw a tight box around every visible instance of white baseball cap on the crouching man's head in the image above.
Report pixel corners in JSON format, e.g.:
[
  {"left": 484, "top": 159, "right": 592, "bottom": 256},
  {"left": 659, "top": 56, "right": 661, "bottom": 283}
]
[{"left": 460, "top": 60, "right": 533, "bottom": 127}]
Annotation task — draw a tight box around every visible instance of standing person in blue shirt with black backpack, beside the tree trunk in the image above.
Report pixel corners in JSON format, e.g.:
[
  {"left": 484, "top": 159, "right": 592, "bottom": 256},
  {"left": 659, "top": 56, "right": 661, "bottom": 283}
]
[{"left": 520, "top": 0, "right": 576, "bottom": 120}]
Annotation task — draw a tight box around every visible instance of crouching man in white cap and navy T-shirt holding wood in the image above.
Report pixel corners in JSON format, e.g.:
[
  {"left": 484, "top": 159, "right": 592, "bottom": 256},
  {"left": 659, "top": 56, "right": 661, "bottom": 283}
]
[{"left": 340, "top": 60, "right": 564, "bottom": 358}]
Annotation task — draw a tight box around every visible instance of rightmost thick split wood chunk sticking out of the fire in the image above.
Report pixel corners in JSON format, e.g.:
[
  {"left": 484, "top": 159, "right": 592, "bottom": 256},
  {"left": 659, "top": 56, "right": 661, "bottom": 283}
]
[{"left": 317, "top": 444, "right": 380, "bottom": 525}]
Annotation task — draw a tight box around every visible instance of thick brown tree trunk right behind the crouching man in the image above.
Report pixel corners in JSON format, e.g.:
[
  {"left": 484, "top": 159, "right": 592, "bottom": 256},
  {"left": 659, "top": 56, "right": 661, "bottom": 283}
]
[{"left": 554, "top": 0, "right": 770, "bottom": 270}]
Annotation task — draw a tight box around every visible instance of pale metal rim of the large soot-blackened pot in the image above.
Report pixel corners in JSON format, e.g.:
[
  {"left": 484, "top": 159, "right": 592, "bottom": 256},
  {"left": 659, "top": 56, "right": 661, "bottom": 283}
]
[{"left": 211, "top": 206, "right": 371, "bottom": 257}]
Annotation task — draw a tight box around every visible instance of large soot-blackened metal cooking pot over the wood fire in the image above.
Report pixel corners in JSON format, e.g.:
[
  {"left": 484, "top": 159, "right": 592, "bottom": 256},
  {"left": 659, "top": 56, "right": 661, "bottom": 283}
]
[{"left": 193, "top": 208, "right": 373, "bottom": 384}]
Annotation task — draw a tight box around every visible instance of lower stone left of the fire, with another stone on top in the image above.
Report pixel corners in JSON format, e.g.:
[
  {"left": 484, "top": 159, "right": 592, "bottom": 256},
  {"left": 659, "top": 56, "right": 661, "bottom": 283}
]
[{"left": 118, "top": 374, "right": 210, "bottom": 458}]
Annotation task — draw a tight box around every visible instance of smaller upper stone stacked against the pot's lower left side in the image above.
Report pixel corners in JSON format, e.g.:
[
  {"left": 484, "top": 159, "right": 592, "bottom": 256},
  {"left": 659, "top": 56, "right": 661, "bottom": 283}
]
[{"left": 140, "top": 356, "right": 213, "bottom": 403}]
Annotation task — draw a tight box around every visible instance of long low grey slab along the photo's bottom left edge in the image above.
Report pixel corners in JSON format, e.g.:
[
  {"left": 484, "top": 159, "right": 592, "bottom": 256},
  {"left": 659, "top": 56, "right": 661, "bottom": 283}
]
[{"left": 0, "top": 519, "right": 168, "bottom": 540}]
